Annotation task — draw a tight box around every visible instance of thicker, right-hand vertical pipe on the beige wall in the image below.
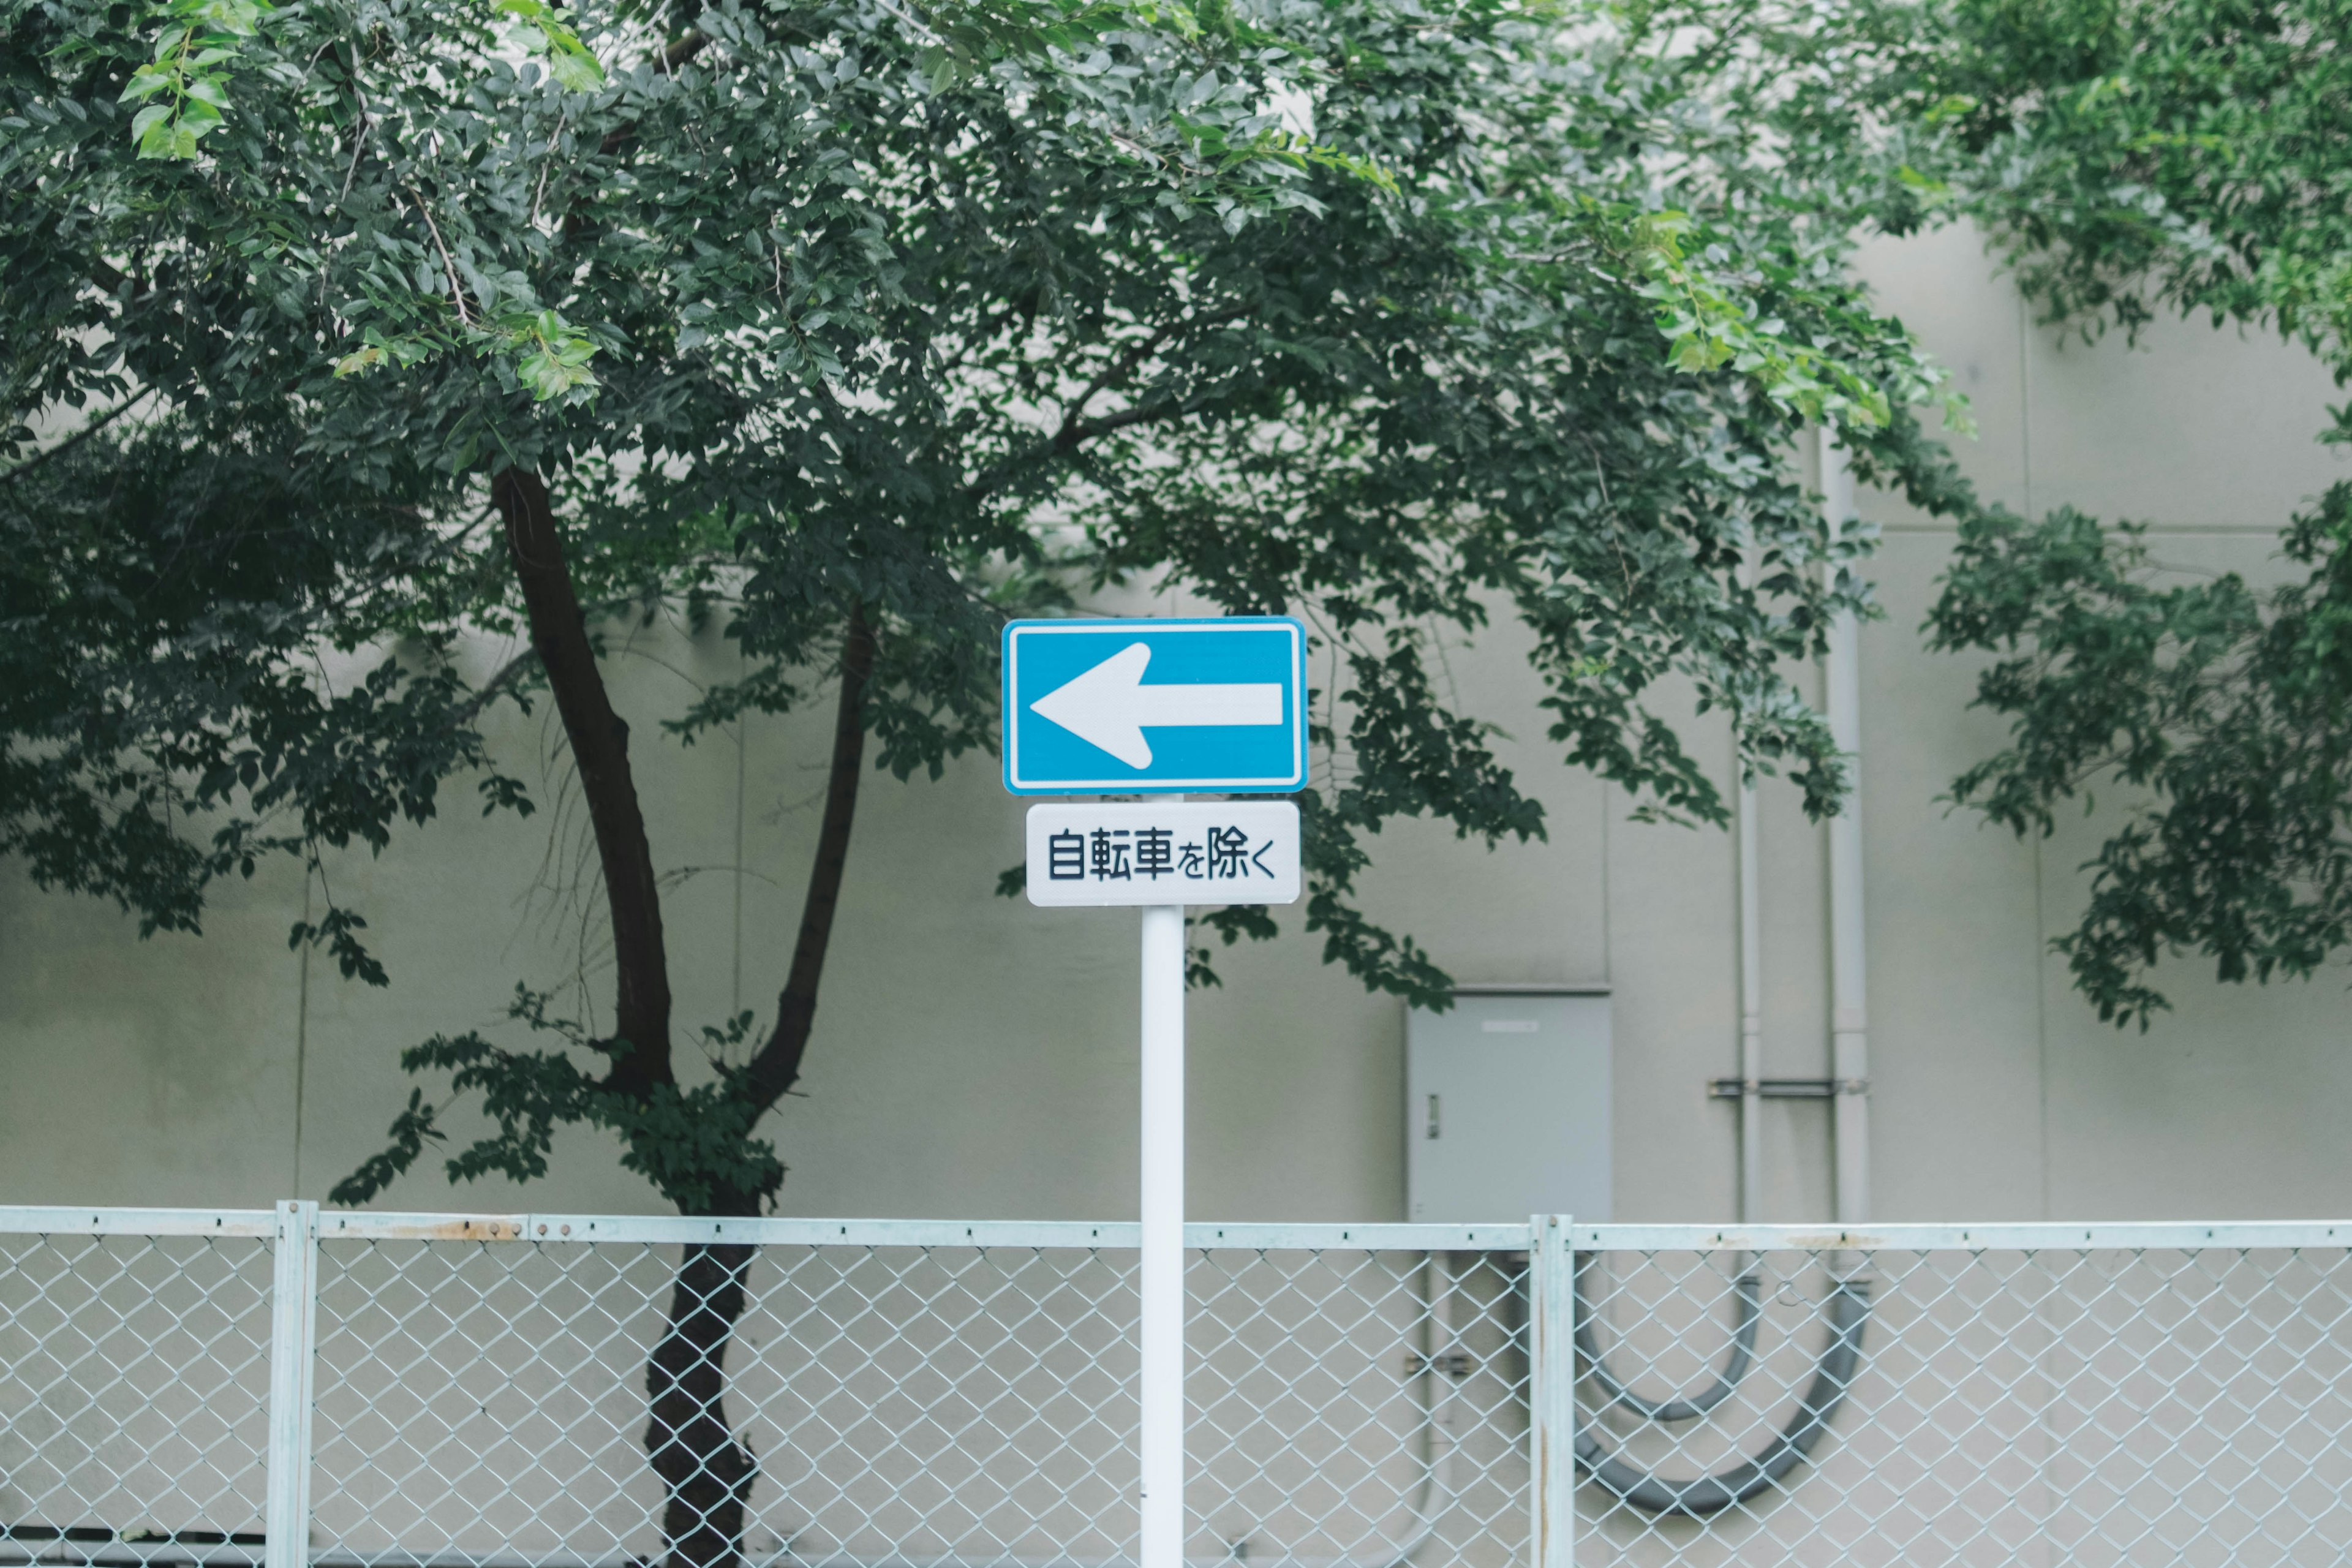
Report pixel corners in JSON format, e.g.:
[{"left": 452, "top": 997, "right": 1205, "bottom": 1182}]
[{"left": 1818, "top": 430, "right": 1870, "bottom": 1225}]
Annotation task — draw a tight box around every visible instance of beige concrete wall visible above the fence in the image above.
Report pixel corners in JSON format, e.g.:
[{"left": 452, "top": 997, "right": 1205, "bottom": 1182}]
[{"left": 0, "top": 233, "right": 2352, "bottom": 1220}]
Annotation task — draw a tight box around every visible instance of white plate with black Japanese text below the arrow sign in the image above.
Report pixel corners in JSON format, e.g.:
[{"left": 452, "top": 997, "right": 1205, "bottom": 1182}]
[{"left": 1028, "top": 799, "right": 1298, "bottom": 910}]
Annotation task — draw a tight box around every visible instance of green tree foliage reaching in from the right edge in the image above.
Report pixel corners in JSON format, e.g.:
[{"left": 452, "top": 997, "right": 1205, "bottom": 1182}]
[{"left": 1825, "top": 0, "right": 2352, "bottom": 1027}]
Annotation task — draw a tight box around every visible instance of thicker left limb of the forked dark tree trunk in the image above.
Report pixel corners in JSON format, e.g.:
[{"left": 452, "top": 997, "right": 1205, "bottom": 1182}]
[{"left": 489, "top": 468, "right": 675, "bottom": 1098}]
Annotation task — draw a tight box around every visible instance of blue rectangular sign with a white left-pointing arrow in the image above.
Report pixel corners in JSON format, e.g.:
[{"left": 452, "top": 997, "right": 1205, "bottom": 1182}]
[{"left": 1005, "top": 616, "right": 1308, "bottom": 794}]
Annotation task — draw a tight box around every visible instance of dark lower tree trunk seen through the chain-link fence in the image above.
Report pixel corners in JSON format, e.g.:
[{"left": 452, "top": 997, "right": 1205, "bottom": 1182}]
[{"left": 644, "top": 1243, "right": 760, "bottom": 1568}]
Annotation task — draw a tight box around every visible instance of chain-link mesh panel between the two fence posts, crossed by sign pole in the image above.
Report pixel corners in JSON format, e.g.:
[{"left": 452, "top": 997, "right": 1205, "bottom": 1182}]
[{"left": 313, "top": 1242, "right": 1526, "bottom": 1568}]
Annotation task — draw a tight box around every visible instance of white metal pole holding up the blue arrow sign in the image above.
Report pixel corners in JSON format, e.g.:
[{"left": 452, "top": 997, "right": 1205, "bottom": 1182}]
[{"left": 1139, "top": 903, "right": 1183, "bottom": 1568}]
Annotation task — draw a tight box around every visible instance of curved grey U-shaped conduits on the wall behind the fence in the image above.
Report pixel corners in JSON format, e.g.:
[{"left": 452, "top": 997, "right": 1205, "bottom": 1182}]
[{"left": 1571, "top": 1253, "right": 1870, "bottom": 1518}]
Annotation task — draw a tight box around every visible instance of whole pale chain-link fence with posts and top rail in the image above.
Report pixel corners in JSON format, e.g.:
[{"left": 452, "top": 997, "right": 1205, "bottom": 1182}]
[{"left": 0, "top": 1204, "right": 2352, "bottom": 1568}]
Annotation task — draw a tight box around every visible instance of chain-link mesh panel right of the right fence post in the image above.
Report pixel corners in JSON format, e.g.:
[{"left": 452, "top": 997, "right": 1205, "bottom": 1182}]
[{"left": 1580, "top": 1248, "right": 2352, "bottom": 1568}]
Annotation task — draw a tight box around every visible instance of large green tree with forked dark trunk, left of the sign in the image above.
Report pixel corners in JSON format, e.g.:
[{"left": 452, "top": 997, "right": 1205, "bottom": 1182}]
[{"left": 0, "top": 0, "right": 1948, "bottom": 1568}]
